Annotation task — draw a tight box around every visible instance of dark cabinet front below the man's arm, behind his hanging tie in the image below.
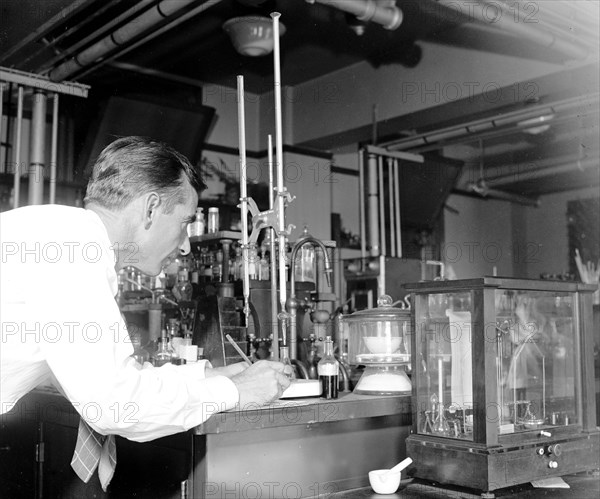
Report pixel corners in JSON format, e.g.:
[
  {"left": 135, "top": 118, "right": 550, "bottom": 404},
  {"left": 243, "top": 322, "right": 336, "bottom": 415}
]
[{"left": 0, "top": 392, "right": 193, "bottom": 499}]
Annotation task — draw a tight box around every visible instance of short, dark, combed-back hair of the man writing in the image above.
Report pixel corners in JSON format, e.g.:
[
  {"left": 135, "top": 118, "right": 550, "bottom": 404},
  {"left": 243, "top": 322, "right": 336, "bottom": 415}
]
[{"left": 84, "top": 136, "right": 206, "bottom": 213}]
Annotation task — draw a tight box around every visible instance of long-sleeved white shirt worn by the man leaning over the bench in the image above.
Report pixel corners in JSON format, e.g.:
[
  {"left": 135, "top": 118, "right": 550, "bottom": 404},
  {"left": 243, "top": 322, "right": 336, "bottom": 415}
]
[{"left": 0, "top": 205, "right": 239, "bottom": 442}]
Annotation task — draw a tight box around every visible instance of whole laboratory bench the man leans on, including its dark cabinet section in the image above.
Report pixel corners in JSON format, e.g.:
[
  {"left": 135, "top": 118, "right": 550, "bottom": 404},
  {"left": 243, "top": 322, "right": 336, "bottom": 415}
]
[{"left": 0, "top": 389, "right": 411, "bottom": 499}]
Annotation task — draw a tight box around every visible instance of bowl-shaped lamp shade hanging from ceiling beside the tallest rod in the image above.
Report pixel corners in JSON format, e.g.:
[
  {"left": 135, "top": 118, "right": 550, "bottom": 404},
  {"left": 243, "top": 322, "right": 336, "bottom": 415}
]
[{"left": 223, "top": 16, "right": 285, "bottom": 57}]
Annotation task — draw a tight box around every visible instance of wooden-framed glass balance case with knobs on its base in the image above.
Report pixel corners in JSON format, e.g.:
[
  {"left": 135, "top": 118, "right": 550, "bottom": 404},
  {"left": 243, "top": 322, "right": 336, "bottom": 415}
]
[{"left": 406, "top": 277, "right": 600, "bottom": 492}]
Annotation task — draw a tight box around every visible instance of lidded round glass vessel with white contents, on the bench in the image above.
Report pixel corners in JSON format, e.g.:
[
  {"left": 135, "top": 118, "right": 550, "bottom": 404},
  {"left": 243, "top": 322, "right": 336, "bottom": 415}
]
[{"left": 342, "top": 295, "right": 412, "bottom": 395}]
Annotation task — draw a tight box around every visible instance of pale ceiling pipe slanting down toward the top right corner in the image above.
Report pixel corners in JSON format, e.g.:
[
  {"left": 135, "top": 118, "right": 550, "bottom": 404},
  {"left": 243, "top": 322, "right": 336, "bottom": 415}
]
[{"left": 437, "top": 0, "right": 589, "bottom": 60}]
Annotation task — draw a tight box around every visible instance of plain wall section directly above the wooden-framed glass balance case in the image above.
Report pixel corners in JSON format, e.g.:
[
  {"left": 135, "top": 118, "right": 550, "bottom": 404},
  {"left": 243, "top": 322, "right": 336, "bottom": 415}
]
[{"left": 442, "top": 187, "right": 600, "bottom": 279}]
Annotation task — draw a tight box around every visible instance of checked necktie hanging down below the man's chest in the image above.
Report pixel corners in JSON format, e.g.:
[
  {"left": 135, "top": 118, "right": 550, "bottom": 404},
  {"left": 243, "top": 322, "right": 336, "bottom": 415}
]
[{"left": 71, "top": 419, "right": 117, "bottom": 492}]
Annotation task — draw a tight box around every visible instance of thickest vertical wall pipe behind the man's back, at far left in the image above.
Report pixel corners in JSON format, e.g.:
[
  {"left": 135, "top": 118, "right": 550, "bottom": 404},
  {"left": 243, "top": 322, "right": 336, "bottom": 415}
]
[{"left": 29, "top": 89, "right": 48, "bottom": 205}]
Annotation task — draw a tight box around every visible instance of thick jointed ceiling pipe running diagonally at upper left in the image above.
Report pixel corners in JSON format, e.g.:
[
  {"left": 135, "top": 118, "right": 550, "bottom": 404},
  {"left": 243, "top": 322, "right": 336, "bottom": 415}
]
[{"left": 48, "top": 0, "right": 217, "bottom": 81}]
